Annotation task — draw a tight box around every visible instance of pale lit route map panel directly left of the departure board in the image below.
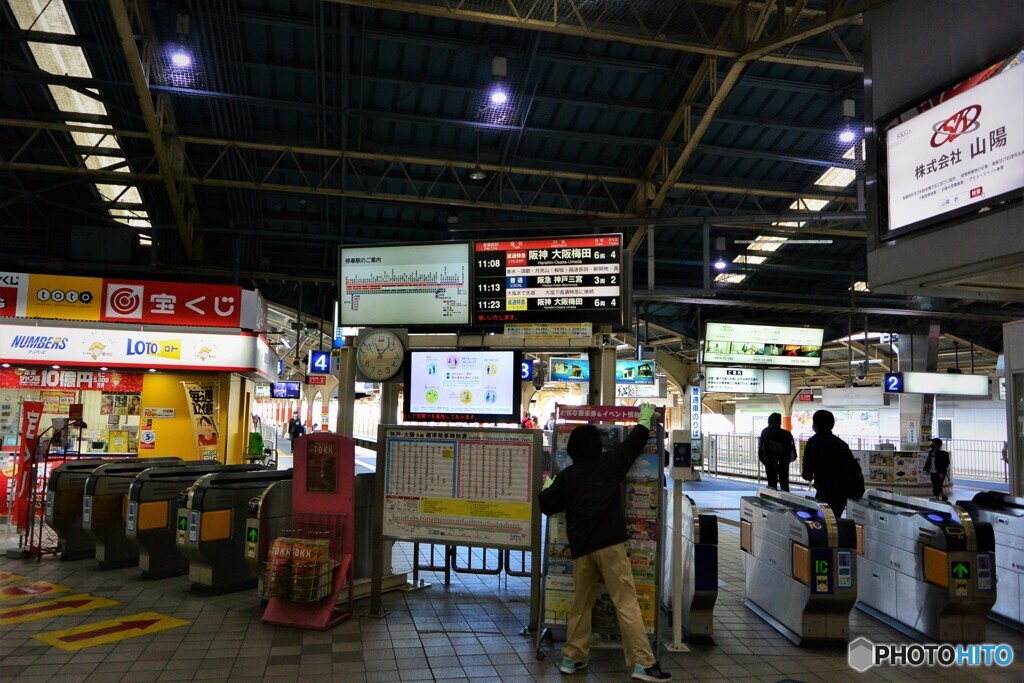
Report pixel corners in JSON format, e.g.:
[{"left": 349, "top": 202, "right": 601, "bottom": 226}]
[{"left": 338, "top": 242, "right": 471, "bottom": 327}]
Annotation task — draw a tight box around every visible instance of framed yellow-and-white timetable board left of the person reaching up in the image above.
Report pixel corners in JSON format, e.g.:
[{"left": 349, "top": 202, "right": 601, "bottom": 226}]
[{"left": 377, "top": 426, "right": 543, "bottom": 550}]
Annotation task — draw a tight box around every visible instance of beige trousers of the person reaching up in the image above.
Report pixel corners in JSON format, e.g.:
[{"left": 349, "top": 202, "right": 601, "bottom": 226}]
[{"left": 562, "top": 543, "right": 654, "bottom": 668}]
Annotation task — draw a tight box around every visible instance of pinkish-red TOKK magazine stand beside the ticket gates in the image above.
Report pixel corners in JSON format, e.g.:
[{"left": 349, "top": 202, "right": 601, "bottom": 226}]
[{"left": 263, "top": 432, "right": 355, "bottom": 631}]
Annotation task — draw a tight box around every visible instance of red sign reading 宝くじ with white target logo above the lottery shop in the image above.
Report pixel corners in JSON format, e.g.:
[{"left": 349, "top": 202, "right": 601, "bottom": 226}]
[{"left": 99, "top": 280, "right": 242, "bottom": 328}]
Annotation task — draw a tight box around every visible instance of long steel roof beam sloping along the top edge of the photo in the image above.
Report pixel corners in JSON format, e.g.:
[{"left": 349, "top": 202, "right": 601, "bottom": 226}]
[{"left": 331, "top": 0, "right": 863, "bottom": 72}]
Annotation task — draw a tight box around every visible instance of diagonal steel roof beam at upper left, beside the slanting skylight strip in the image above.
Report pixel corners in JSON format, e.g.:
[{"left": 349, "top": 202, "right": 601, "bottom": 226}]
[{"left": 110, "top": 0, "right": 198, "bottom": 262}]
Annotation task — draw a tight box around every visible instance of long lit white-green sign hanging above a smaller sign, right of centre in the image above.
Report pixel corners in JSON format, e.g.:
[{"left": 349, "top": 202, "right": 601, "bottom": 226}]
[{"left": 703, "top": 323, "right": 824, "bottom": 368}]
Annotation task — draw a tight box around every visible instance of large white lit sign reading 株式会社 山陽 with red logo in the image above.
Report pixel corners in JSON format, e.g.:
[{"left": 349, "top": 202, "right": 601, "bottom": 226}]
[{"left": 880, "top": 46, "right": 1024, "bottom": 239}]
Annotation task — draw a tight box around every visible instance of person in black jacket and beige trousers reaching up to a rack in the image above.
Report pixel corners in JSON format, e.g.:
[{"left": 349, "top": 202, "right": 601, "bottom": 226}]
[{"left": 540, "top": 403, "right": 672, "bottom": 681}]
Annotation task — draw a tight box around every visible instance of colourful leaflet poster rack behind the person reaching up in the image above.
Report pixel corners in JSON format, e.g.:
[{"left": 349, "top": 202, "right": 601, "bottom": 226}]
[{"left": 544, "top": 413, "right": 664, "bottom": 636}]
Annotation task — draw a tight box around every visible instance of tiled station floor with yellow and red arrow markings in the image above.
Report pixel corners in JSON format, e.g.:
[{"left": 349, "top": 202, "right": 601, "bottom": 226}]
[{"left": 0, "top": 477, "right": 1024, "bottom": 683}]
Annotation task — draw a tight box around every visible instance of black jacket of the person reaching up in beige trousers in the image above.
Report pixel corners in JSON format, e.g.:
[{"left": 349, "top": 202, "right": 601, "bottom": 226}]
[{"left": 540, "top": 425, "right": 650, "bottom": 559}]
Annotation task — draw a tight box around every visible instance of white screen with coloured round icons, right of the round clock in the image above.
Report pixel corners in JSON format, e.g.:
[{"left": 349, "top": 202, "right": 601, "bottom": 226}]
[{"left": 404, "top": 349, "right": 522, "bottom": 423}]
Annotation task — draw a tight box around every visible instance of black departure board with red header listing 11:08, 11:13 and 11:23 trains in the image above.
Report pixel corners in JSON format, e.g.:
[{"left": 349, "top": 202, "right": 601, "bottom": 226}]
[{"left": 473, "top": 234, "right": 625, "bottom": 326}]
